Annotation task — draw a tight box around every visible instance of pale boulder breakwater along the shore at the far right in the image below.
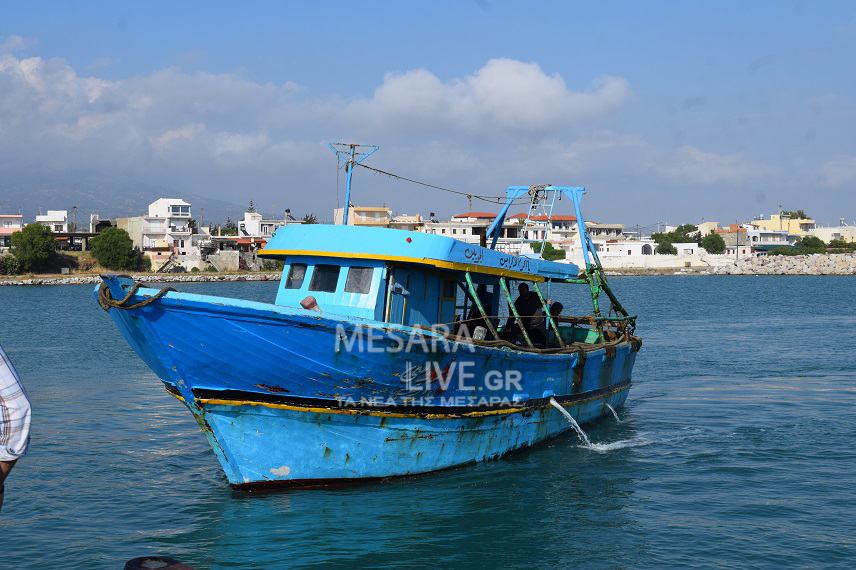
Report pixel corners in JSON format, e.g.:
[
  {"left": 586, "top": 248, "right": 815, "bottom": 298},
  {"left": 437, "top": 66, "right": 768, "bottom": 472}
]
[{"left": 708, "top": 253, "right": 856, "bottom": 275}]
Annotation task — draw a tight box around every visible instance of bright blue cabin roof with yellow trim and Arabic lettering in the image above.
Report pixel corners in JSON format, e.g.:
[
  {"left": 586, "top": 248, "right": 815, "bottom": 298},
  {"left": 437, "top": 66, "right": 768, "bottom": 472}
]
[{"left": 259, "top": 224, "right": 579, "bottom": 281}]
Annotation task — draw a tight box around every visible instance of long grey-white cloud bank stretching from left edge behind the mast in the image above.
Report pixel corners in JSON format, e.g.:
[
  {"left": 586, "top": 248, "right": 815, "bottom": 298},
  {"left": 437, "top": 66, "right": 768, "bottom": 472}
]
[{"left": 0, "top": 46, "right": 796, "bottom": 222}]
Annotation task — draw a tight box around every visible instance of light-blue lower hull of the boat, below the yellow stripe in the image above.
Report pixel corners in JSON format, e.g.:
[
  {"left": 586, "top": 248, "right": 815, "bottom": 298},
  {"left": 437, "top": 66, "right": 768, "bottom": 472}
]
[{"left": 197, "top": 384, "right": 630, "bottom": 487}]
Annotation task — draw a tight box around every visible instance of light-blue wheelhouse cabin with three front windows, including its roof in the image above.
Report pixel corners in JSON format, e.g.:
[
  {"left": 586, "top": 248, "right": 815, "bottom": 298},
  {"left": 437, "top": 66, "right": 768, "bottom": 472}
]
[{"left": 259, "top": 225, "right": 612, "bottom": 344}]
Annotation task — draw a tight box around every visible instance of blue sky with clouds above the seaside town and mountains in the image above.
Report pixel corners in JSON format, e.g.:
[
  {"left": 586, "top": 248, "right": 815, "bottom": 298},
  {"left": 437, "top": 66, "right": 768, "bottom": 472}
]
[{"left": 0, "top": 0, "right": 856, "bottom": 227}]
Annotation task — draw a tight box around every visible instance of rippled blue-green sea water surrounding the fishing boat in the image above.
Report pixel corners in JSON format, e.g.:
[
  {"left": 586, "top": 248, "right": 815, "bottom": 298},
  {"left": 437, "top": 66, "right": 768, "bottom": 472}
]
[{"left": 0, "top": 276, "right": 856, "bottom": 568}]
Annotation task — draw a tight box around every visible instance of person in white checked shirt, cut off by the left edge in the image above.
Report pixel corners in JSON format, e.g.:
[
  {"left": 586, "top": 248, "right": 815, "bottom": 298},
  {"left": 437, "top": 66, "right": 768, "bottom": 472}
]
[{"left": 0, "top": 346, "right": 30, "bottom": 509}]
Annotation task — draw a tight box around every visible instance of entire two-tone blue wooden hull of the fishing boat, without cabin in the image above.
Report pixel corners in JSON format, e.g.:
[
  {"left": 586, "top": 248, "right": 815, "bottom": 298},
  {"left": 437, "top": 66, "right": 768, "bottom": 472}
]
[{"left": 97, "top": 277, "right": 639, "bottom": 487}]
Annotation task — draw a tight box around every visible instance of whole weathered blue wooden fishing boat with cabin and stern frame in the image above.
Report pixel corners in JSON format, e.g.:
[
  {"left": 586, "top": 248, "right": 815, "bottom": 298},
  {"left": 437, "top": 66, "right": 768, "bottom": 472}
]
[{"left": 96, "top": 180, "right": 641, "bottom": 487}]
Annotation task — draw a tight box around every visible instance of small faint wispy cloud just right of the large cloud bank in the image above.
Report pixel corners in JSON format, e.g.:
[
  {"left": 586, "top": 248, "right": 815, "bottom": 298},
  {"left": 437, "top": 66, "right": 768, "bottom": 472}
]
[{"left": 649, "top": 145, "right": 767, "bottom": 185}]
